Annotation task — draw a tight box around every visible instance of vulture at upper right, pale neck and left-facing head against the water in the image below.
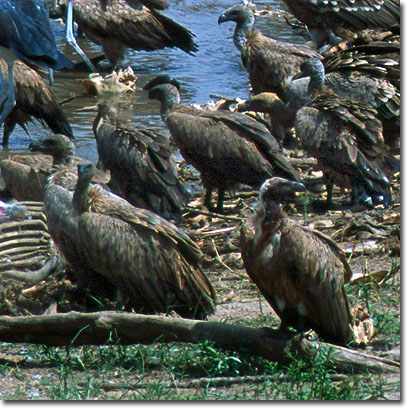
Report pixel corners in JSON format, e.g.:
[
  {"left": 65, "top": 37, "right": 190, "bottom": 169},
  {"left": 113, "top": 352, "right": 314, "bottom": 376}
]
[{"left": 218, "top": 5, "right": 320, "bottom": 101}]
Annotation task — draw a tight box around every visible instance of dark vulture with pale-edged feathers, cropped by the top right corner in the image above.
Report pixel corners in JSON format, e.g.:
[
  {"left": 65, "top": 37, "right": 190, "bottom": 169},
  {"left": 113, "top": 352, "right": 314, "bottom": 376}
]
[{"left": 283, "top": 0, "right": 400, "bottom": 47}]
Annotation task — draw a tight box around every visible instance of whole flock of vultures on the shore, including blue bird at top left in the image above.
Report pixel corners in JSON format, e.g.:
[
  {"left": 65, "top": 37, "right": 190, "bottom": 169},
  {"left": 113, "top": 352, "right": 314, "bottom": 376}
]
[{"left": 0, "top": 0, "right": 400, "bottom": 345}]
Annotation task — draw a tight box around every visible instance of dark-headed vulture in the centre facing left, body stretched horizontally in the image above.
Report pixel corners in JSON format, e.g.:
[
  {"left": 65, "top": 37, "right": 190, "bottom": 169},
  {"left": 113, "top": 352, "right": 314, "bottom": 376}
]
[{"left": 144, "top": 75, "right": 300, "bottom": 212}]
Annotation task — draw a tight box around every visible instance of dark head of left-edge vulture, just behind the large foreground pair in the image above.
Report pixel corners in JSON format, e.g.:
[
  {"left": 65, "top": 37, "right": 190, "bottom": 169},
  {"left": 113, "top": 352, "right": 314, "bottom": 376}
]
[{"left": 29, "top": 134, "right": 75, "bottom": 166}]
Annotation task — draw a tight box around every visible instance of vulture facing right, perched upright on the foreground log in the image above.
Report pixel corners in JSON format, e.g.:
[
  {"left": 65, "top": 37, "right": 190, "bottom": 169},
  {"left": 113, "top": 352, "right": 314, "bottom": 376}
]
[{"left": 241, "top": 177, "right": 353, "bottom": 345}]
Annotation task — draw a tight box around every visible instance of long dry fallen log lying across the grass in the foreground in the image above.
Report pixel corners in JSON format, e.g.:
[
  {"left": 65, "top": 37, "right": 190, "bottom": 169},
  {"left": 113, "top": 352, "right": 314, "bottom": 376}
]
[{"left": 0, "top": 312, "right": 400, "bottom": 373}]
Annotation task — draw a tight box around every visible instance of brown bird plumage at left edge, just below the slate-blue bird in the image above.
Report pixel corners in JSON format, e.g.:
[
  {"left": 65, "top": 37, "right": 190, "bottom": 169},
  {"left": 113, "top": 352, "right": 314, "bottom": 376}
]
[{"left": 0, "top": 59, "right": 74, "bottom": 145}]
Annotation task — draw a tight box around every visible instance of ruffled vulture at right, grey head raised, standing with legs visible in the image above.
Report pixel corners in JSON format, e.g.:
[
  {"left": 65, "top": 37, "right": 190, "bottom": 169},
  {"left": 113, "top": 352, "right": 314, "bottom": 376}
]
[{"left": 295, "top": 59, "right": 400, "bottom": 208}]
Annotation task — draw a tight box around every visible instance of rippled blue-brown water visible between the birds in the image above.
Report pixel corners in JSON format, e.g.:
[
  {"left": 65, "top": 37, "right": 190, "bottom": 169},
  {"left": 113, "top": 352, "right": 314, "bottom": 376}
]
[{"left": 0, "top": 0, "right": 305, "bottom": 161}]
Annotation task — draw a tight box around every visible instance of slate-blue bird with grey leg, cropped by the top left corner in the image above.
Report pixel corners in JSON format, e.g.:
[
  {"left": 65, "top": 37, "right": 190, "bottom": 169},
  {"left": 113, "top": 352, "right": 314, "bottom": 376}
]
[{"left": 0, "top": 0, "right": 73, "bottom": 126}]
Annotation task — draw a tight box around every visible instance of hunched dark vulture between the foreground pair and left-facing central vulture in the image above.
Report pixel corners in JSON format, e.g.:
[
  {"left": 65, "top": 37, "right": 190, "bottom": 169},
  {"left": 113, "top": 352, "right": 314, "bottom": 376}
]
[{"left": 93, "top": 101, "right": 189, "bottom": 219}]
